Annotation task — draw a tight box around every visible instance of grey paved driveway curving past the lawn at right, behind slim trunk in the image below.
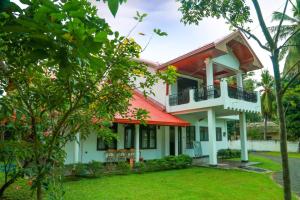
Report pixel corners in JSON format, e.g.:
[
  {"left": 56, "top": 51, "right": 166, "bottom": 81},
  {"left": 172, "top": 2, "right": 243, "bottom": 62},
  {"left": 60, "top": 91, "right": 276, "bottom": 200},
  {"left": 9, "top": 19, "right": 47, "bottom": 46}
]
[{"left": 257, "top": 153, "right": 300, "bottom": 196}]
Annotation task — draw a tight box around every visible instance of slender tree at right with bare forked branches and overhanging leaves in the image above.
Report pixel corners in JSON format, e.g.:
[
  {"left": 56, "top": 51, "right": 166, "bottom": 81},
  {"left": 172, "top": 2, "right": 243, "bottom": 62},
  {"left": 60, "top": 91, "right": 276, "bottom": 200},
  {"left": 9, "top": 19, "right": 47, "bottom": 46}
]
[{"left": 178, "top": 0, "right": 300, "bottom": 200}]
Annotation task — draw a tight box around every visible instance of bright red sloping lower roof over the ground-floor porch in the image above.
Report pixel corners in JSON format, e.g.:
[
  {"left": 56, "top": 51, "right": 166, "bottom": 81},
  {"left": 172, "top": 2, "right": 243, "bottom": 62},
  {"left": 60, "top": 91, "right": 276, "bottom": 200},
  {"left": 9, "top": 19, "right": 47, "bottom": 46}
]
[{"left": 114, "top": 91, "right": 190, "bottom": 126}]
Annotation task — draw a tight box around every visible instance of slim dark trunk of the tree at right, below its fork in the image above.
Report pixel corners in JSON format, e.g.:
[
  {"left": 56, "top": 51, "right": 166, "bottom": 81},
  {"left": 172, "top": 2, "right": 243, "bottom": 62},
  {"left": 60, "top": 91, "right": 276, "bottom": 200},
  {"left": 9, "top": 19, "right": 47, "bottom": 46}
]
[{"left": 271, "top": 52, "right": 292, "bottom": 200}]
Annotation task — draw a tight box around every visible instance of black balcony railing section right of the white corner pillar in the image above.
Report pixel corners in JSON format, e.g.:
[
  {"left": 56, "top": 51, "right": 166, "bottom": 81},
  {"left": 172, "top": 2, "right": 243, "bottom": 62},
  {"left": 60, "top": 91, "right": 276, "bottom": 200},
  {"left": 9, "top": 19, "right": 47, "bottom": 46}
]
[{"left": 228, "top": 86, "right": 257, "bottom": 103}]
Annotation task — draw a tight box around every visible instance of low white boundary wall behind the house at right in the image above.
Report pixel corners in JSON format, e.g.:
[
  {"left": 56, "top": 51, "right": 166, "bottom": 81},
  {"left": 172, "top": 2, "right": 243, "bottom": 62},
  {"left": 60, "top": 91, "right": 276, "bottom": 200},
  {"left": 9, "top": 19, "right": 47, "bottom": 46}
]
[{"left": 228, "top": 140, "right": 299, "bottom": 152}]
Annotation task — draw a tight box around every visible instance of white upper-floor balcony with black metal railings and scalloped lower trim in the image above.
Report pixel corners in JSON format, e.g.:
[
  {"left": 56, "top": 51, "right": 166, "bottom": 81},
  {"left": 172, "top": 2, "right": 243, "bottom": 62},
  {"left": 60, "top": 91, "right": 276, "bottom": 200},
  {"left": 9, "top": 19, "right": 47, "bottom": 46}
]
[{"left": 166, "top": 79, "right": 261, "bottom": 114}]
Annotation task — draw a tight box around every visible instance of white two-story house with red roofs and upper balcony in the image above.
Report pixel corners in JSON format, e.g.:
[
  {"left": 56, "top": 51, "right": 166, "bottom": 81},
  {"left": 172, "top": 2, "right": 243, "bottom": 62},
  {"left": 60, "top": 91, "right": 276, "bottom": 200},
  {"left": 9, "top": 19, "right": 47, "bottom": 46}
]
[{"left": 66, "top": 32, "right": 262, "bottom": 165}]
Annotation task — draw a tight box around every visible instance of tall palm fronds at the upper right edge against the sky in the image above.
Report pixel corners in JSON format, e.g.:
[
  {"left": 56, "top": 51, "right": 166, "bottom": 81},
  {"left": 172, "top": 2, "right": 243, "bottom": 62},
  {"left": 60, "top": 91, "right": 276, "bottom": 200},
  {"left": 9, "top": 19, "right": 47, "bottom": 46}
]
[{"left": 270, "top": 0, "right": 300, "bottom": 75}]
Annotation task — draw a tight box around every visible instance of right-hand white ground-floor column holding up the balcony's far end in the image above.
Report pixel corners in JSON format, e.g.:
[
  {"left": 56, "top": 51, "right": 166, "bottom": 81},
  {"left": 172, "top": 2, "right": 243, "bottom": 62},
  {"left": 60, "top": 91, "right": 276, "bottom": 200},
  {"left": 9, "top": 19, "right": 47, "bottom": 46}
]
[{"left": 239, "top": 112, "right": 248, "bottom": 162}]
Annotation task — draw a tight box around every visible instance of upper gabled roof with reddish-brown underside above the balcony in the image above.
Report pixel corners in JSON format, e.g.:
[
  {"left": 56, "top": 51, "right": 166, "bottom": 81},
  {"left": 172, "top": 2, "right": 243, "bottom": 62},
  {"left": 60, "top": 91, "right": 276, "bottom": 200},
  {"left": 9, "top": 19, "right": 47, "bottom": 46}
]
[{"left": 158, "top": 31, "right": 263, "bottom": 78}]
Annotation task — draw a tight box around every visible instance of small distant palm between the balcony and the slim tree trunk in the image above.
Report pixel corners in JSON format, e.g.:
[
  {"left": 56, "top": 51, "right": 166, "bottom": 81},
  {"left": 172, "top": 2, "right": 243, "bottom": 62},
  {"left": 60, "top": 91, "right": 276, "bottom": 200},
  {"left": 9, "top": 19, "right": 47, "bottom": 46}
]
[{"left": 257, "top": 70, "right": 276, "bottom": 140}]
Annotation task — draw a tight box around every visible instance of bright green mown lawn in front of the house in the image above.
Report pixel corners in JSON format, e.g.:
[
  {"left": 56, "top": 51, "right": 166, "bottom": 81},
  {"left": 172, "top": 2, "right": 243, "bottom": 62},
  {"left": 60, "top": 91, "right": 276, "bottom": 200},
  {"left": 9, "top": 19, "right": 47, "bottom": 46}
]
[{"left": 65, "top": 168, "right": 282, "bottom": 200}]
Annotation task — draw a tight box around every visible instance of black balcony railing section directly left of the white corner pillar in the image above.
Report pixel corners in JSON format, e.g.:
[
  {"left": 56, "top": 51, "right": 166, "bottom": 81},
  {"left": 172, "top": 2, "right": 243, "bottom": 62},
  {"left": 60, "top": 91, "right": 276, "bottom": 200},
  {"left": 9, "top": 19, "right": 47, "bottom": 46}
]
[{"left": 194, "top": 85, "right": 221, "bottom": 102}]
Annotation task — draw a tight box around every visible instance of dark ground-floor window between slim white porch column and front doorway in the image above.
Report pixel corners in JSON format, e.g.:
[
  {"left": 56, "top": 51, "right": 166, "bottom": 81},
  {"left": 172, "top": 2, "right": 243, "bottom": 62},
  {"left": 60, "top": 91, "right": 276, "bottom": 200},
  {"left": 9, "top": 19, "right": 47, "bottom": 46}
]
[{"left": 140, "top": 125, "right": 156, "bottom": 149}]
